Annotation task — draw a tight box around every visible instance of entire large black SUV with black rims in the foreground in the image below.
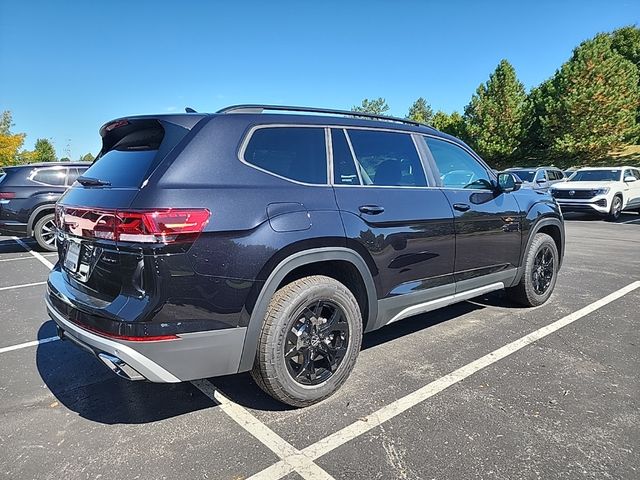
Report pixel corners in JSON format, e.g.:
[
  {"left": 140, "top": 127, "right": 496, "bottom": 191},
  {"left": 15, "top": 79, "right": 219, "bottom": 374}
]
[{"left": 46, "top": 105, "right": 564, "bottom": 406}]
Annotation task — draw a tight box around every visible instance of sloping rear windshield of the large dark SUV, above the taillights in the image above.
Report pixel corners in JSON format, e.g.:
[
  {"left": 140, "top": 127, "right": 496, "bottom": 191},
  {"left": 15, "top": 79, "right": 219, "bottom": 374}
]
[{"left": 82, "top": 150, "right": 158, "bottom": 188}]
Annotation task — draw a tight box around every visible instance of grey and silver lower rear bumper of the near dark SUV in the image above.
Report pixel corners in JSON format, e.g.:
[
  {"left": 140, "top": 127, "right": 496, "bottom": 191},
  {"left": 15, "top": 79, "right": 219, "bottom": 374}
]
[{"left": 45, "top": 298, "right": 246, "bottom": 383}]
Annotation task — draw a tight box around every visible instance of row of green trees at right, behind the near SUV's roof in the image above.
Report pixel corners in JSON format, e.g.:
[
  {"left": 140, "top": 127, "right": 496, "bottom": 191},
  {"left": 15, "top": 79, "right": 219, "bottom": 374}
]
[{"left": 352, "top": 26, "right": 640, "bottom": 168}]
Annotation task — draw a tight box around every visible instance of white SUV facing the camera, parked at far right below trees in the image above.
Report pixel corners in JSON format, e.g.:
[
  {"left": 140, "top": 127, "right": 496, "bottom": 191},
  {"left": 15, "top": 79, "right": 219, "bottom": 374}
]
[{"left": 550, "top": 167, "right": 640, "bottom": 220}]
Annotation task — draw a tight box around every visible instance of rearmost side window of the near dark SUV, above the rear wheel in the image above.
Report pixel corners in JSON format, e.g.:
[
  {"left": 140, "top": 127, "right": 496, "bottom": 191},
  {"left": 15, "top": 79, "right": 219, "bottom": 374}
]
[{"left": 244, "top": 127, "right": 327, "bottom": 184}]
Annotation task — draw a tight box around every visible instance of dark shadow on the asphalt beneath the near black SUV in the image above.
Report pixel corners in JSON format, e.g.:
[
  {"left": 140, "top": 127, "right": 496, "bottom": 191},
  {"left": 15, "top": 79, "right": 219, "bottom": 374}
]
[{"left": 36, "top": 294, "right": 510, "bottom": 424}]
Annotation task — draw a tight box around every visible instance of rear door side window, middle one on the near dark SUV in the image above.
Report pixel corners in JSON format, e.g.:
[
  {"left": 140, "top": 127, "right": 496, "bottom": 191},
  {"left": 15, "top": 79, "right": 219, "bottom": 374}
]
[{"left": 348, "top": 130, "right": 427, "bottom": 187}]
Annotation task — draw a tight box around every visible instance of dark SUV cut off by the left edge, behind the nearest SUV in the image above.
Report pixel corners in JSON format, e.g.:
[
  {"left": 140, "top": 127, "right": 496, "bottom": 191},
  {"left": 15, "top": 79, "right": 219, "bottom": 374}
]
[{"left": 0, "top": 162, "right": 90, "bottom": 251}]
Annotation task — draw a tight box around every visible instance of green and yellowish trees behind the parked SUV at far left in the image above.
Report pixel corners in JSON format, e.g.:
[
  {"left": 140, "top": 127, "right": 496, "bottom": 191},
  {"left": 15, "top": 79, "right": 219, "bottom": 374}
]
[{"left": 0, "top": 111, "right": 95, "bottom": 167}]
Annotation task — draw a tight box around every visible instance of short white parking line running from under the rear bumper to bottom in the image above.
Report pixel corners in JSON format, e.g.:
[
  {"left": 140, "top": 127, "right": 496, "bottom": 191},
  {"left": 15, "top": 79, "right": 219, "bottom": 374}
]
[{"left": 191, "top": 380, "right": 333, "bottom": 480}]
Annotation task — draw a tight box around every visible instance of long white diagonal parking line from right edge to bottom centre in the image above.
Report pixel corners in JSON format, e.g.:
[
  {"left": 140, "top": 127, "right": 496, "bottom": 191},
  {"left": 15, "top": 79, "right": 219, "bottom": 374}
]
[{"left": 249, "top": 281, "right": 640, "bottom": 480}]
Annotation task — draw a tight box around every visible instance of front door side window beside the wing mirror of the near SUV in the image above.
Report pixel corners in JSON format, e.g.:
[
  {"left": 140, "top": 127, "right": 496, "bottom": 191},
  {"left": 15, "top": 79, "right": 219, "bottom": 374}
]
[{"left": 425, "top": 137, "right": 491, "bottom": 189}]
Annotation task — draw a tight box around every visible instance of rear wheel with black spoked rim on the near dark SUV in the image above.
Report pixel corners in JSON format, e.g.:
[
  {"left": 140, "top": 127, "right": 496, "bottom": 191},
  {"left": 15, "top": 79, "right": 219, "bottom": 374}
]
[{"left": 251, "top": 275, "right": 362, "bottom": 407}]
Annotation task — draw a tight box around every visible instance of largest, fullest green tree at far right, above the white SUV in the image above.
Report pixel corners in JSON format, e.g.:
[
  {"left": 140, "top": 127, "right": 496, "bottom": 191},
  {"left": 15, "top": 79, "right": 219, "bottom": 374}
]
[{"left": 536, "top": 34, "right": 640, "bottom": 160}]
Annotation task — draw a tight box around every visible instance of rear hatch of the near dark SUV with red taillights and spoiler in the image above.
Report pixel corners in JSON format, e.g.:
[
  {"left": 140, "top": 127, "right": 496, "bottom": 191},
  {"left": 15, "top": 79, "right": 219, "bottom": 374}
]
[{"left": 49, "top": 115, "right": 208, "bottom": 333}]
